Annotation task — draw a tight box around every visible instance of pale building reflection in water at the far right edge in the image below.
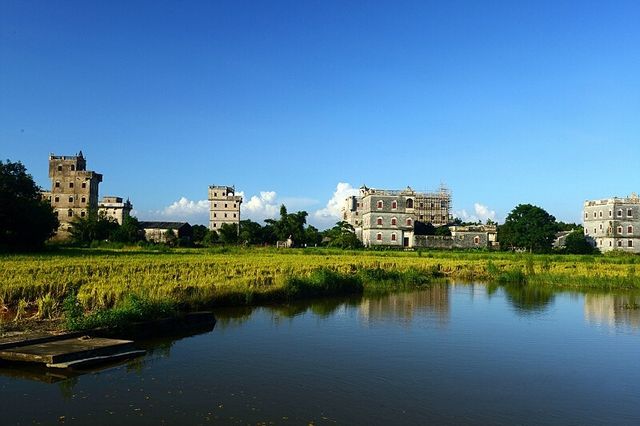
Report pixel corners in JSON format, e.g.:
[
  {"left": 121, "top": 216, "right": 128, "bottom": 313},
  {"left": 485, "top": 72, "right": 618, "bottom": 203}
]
[{"left": 584, "top": 294, "right": 640, "bottom": 328}]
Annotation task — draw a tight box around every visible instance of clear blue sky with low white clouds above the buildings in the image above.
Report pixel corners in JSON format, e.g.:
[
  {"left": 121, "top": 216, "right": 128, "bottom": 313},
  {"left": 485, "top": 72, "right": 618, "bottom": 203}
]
[{"left": 0, "top": 0, "right": 640, "bottom": 230}]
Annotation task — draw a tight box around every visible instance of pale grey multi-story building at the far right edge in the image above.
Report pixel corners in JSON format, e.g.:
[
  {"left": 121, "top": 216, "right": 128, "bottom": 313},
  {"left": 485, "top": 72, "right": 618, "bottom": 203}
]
[{"left": 583, "top": 194, "right": 640, "bottom": 253}]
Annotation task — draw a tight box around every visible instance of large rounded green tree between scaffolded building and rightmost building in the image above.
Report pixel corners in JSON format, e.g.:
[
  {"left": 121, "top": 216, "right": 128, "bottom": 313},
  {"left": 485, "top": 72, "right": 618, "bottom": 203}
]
[{"left": 498, "top": 204, "right": 556, "bottom": 252}]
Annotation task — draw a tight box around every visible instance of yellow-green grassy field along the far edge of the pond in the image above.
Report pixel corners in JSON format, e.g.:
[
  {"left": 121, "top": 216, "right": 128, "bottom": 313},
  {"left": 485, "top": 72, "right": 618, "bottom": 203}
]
[{"left": 0, "top": 248, "right": 640, "bottom": 330}]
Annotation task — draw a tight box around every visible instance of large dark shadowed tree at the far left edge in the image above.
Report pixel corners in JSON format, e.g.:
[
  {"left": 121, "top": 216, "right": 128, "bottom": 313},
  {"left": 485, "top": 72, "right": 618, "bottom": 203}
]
[{"left": 0, "top": 160, "right": 59, "bottom": 250}]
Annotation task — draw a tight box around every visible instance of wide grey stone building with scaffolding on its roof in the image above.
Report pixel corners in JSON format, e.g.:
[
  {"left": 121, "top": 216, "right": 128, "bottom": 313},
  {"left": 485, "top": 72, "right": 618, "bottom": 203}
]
[{"left": 342, "top": 186, "right": 451, "bottom": 247}]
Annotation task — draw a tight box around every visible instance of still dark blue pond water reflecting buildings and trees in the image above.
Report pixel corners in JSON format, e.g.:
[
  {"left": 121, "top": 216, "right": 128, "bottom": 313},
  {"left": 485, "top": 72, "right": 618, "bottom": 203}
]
[{"left": 0, "top": 284, "right": 640, "bottom": 425}]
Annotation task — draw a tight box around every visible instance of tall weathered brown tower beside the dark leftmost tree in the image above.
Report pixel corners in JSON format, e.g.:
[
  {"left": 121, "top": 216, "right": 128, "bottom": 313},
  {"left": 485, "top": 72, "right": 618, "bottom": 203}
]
[{"left": 47, "top": 151, "right": 102, "bottom": 239}]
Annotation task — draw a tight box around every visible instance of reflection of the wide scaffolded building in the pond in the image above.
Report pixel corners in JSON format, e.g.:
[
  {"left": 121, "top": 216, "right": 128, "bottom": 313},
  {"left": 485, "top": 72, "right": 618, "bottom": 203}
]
[{"left": 359, "top": 284, "right": 449, "bottom": 324}]
